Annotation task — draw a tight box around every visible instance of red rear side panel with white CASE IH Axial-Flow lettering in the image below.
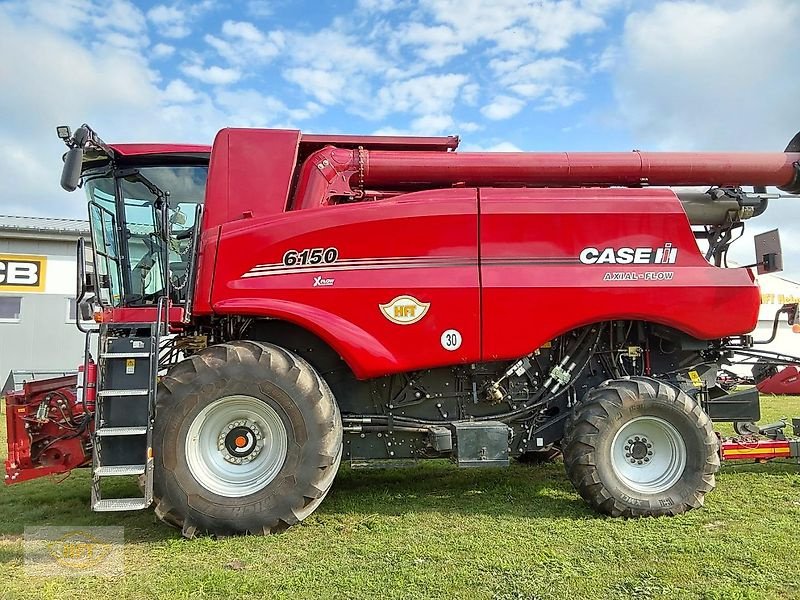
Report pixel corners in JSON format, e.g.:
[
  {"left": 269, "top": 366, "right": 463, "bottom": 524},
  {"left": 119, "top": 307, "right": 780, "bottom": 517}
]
[{"left": 480, "top": 188, "right": 760, "bottom": 360}]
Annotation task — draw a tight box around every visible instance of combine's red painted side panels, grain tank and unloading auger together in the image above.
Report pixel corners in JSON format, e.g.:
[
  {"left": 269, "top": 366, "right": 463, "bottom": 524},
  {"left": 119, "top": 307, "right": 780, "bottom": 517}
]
[{"left": 101, "top": 129, "right": 788, "bottom": 377}]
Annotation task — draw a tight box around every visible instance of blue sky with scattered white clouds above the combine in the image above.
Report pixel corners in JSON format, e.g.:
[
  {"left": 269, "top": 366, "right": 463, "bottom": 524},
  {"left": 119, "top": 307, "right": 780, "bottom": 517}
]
[{"left": 0, "top": 0, "right": 800, "bottom": 279}]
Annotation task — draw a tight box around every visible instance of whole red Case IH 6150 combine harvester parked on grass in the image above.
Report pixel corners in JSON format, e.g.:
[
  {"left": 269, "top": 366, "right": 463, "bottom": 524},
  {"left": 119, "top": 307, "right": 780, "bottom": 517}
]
[{"left": 6, "top": 125, "right": 800, "bottom": 537}]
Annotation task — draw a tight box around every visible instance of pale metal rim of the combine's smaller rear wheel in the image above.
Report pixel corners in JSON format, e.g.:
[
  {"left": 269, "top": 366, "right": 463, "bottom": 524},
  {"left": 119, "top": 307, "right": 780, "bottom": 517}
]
[{"left": 611, "top": 417, "right": 686, "bottom": 494}]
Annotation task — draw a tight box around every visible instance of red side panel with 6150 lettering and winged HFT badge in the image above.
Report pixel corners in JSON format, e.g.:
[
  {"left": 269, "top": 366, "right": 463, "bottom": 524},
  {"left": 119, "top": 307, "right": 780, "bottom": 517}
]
[{"left": 212, "top": 189, "right": 480, "bottom": 378}]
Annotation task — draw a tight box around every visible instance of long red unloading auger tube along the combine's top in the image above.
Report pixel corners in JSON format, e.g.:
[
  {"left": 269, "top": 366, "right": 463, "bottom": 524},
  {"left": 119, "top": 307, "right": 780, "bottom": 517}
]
[{"left": 292, "top": 134, "right": 800, "bottom": 225}]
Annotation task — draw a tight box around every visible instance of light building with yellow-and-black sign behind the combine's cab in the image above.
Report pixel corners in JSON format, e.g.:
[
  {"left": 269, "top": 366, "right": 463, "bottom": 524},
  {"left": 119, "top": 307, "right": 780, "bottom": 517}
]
[{"left": 0, "top": 215, "right": 89, "bottom": 390}]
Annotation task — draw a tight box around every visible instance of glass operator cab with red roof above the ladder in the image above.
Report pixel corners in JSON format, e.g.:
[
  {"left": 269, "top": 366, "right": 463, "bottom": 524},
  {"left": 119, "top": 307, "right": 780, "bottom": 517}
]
[{"left": 59, "top": 125, "right": 210, "bottom": 308}]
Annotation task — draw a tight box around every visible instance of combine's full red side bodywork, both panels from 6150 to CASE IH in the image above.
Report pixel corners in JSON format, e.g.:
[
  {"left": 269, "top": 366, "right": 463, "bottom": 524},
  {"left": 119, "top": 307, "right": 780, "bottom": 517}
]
[{"left": 208, "top": 183, "right": 759, "bottom": 378}]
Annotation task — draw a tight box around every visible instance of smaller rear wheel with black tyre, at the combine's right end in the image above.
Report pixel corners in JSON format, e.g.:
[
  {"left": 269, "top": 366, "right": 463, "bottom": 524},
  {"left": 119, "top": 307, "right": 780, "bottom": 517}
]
[{"left": 563, "top": 377, "right": 719, "bottom": 517}]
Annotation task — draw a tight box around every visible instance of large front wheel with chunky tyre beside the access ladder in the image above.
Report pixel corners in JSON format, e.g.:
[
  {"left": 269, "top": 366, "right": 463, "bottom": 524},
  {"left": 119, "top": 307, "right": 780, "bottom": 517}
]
[{"left": 153, "top": 341, "right": 342, "bottom": 537}]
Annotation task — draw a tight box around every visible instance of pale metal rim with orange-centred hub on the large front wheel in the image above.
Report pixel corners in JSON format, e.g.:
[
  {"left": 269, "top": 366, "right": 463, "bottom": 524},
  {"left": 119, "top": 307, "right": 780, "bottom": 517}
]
[{"left": 185, "top": 395, "right": 288, "bottom": 498}]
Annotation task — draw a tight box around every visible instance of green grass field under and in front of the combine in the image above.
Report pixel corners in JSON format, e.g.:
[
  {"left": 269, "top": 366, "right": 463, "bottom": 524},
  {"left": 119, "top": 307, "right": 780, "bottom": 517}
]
[{"left": 0, "top": 397, "right": 800, "bottom": 600}]
